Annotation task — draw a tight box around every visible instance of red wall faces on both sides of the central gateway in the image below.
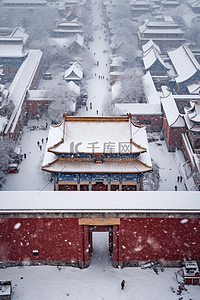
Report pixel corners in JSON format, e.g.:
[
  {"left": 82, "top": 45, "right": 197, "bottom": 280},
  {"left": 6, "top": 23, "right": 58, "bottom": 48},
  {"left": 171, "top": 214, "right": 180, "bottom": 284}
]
[{"left": 0, "top": 218, "right": 200, "bottom": 262}]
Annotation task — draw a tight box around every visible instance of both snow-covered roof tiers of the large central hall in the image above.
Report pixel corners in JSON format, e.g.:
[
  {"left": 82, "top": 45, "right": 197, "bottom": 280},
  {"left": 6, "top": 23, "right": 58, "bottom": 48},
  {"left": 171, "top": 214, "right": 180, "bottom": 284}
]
[{"left": 42, "top": 116, "right": 151, "bottom": 173}]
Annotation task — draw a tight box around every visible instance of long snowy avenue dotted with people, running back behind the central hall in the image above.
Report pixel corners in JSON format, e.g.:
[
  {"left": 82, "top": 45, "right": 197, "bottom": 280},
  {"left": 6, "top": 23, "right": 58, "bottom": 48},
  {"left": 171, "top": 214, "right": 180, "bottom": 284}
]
[{"left": 78, "top": 1, "right": 111, "bottom": 116}]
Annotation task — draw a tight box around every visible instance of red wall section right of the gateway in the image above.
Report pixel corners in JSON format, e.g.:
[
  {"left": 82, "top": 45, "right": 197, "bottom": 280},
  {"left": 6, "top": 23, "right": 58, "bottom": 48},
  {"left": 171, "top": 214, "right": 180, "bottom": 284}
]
[{"left": 119, "top": 218, "right": 200, "bottom": 261}]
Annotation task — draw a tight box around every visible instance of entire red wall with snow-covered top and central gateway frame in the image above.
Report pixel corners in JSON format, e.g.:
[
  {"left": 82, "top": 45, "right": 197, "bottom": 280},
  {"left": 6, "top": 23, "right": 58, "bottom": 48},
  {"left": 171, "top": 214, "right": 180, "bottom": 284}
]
[{"left": 0, "top": 191, "right": 200, "bottom": 268}]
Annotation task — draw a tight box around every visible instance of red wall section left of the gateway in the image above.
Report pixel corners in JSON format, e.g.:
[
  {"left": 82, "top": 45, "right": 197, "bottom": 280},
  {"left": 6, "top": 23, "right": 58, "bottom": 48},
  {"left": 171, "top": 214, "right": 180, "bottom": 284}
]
[{"left": 0, "top": 218, "right": 83, "bottom": 261}]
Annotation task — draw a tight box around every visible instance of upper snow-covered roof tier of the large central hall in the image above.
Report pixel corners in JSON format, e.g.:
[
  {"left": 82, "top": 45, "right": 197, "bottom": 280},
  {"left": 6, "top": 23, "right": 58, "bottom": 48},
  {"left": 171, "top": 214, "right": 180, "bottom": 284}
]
[{"left": 46, "top": 117, "right": 146, "bottom": 153}]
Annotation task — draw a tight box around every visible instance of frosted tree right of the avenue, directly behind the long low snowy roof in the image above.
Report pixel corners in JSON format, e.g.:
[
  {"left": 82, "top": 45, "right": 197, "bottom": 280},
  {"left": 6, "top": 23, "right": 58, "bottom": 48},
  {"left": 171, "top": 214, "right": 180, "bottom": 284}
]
[{"left": 115, "top": 68, "right": 145, "bottom": 103}]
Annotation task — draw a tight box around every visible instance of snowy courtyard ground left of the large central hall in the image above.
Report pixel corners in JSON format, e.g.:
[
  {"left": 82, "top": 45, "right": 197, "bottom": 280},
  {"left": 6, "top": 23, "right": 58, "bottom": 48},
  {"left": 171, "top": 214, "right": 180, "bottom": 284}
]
[{"left": 3, "top": 120, "right": 53, "bottom": 191}]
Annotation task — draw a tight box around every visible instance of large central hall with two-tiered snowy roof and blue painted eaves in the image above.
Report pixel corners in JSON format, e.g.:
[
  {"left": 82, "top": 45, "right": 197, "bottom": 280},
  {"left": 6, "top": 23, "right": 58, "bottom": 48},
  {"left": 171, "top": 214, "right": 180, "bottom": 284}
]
[{"left": 42, "top": 114, "right": 152, "bottom": 191}]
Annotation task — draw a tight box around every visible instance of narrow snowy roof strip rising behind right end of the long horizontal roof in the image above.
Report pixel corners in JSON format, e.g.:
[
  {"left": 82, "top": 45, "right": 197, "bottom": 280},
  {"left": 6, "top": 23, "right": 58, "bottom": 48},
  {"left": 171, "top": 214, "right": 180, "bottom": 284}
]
[{"left": 142, "top": 71, "right": 160, "bottom": 105}]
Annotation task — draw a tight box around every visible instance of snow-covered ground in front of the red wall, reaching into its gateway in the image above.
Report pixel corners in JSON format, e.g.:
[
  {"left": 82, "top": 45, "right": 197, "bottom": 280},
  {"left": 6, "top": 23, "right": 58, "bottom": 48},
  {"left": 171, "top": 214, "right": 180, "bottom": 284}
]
[{"left": 0, "top": 232, "right": 200, "bottom": 300}]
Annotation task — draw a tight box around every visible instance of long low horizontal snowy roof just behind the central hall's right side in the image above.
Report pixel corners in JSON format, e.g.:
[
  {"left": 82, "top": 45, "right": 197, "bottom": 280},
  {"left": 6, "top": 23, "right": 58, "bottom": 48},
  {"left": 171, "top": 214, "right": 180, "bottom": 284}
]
[{"left": 114, "top": 103, "right": 162, "bottom": 115}]
